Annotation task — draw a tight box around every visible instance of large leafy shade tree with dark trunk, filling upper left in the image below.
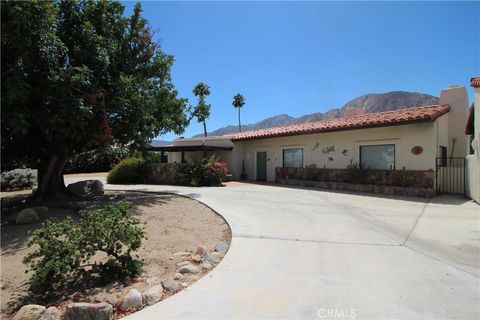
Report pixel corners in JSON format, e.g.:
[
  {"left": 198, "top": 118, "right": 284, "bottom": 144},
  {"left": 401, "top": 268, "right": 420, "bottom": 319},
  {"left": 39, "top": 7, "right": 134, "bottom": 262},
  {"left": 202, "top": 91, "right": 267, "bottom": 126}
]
[{"left": 1, "top": 0, "right": 188, "bottom": 197}]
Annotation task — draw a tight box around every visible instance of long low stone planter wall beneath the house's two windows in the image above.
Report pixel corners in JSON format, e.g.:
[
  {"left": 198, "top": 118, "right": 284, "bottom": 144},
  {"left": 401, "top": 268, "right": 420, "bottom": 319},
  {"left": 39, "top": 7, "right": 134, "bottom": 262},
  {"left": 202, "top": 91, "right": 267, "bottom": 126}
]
[{"left": 275, "top": 168, "right": 436, "bottom": 198}]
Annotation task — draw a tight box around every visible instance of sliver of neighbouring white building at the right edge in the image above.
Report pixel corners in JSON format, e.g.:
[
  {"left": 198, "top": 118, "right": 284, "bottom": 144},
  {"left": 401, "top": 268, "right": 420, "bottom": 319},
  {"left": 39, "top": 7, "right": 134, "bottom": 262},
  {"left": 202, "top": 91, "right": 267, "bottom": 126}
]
[{"left": 465, "top": 77, "right": 480, "bottom": 203}]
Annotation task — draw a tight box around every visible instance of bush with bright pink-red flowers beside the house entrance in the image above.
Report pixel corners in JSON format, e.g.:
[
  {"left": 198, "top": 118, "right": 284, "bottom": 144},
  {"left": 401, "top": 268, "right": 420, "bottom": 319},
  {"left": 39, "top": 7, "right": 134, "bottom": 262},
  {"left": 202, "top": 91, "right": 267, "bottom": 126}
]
[{"left": 182, "top": 155, "right": 228, "bottom": 187}]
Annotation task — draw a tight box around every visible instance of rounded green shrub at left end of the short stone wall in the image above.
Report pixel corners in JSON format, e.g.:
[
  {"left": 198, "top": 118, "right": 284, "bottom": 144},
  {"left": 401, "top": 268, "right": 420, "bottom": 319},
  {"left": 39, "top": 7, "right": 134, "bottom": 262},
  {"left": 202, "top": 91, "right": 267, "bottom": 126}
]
[{"left": 107, "top": 158, "right": 146, "bottom": 184}]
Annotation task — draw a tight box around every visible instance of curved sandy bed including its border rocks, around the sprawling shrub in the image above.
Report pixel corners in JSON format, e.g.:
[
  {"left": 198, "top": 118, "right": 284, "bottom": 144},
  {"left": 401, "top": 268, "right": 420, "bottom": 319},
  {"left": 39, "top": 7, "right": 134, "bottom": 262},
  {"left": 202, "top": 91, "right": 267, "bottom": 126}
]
[{"left": 1, "top": 191, "right": 231, "bottom": 319}]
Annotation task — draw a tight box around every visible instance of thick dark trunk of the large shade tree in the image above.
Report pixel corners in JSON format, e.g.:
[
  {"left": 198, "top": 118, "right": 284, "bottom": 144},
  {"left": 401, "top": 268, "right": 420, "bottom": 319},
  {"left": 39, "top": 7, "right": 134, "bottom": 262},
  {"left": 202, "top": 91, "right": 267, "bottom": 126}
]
[{"left": 37, "top": 155, "right": 69, "bottom": 198}]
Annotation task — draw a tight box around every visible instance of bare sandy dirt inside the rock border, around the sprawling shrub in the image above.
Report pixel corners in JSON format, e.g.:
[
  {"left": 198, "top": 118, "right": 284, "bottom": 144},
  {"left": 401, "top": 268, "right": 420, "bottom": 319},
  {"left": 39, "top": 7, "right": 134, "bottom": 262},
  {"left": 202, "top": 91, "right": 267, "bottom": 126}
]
[{"left": 1, "top": 192, "right": 231, "bottom": 318}]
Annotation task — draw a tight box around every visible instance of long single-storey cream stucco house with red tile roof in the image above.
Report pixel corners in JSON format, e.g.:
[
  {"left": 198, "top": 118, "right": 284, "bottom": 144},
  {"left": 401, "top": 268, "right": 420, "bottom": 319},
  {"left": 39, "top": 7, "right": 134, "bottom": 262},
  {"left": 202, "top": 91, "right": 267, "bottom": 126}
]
[{"left": 157, "top": 86, "right": 468, "bottom": 198}]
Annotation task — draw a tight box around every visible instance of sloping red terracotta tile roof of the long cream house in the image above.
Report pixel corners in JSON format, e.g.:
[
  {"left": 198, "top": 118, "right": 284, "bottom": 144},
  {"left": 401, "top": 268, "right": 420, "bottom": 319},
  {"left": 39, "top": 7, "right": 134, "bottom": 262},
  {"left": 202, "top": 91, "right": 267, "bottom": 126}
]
[{"left": 231, "top": 105, "right": 450, "bottom": 141}]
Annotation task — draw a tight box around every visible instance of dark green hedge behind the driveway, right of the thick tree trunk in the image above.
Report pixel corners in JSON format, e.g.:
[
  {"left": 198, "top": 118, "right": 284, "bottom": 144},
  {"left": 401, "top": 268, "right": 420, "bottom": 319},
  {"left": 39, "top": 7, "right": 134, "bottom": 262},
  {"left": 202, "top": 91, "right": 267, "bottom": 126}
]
[{"left": 64, "top": 146, "right": 129, "bottom": 173}]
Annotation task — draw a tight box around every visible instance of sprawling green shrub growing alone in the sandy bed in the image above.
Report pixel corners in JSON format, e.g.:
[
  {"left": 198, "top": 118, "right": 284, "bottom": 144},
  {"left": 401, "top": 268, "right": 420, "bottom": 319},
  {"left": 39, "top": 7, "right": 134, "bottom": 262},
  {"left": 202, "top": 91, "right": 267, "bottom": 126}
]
[{"left": 23, "top": 202, "right": 145, "bottom": 292}]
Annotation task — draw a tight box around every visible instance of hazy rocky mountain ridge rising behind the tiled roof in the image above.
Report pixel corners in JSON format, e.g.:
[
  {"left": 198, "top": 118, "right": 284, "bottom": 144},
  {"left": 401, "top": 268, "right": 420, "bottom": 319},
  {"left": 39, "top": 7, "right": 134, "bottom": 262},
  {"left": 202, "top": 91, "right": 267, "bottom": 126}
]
[{"left": 194, "top": 91, "right": 439, "bottom": 137}]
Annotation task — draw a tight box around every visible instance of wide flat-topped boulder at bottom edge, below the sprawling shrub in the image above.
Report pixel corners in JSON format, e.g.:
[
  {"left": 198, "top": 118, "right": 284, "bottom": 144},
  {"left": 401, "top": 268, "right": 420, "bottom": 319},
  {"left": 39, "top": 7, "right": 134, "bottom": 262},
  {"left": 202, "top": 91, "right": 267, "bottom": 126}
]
[{"left": 64, "top": 302, "right": 113, "bottom": 320}]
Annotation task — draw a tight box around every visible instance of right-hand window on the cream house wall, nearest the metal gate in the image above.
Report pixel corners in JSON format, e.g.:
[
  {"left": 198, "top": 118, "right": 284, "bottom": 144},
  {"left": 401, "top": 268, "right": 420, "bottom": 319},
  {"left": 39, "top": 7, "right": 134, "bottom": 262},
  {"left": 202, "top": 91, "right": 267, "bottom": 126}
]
[{"left": 360, "top": 144, "right": 395, "bottom": 170}]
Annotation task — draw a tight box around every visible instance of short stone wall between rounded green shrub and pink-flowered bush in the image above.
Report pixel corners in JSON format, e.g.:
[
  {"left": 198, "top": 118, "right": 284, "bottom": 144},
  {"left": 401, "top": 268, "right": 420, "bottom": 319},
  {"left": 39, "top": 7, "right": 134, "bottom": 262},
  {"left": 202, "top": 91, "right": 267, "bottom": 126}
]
[{"left": 145, "top": 163, "right": 189, "bottom": 185}]
